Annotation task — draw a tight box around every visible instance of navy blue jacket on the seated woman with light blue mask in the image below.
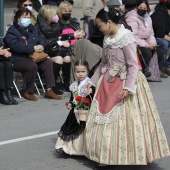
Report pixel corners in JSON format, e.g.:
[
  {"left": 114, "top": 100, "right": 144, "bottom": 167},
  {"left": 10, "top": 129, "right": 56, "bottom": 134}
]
[{"left": 4, "top": 20, "right": 45, "bottom": 63}]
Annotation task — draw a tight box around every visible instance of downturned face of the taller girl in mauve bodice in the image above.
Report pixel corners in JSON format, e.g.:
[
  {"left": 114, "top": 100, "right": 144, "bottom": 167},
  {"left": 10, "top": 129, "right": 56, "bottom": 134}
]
[{"left": 95, "top": 18, "right": 111, "bottom": 35}]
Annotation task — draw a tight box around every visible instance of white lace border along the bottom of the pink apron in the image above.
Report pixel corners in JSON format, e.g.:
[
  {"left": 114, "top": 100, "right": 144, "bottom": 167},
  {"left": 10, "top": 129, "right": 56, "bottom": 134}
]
[{"left": 90, "top": 99, "right": 124, "bottom": 124}]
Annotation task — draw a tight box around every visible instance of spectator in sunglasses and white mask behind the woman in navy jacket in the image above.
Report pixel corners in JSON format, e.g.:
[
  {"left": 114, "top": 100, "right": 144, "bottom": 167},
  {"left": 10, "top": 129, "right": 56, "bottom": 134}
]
[{"left": 17, "top": 0, "right": 38, "bottom": 25}]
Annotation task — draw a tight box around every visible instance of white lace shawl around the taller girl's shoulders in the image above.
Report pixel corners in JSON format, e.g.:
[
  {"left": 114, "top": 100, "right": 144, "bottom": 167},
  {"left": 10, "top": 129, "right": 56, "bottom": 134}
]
[{"left": 103, "top": 24, "right": 136, "bottom": 49}]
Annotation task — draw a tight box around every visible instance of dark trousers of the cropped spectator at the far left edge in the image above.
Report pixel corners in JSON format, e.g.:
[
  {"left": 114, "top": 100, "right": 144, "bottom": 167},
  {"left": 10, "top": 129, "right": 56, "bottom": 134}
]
[{"left": 0, "top": 60, "right": 13, "bottom": 90}]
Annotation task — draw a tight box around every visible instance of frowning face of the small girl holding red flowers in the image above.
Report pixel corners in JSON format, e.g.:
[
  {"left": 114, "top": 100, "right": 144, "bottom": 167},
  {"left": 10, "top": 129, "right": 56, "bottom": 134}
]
[{"left": 75, "top": 65, "right": 88, "bottom": 81}]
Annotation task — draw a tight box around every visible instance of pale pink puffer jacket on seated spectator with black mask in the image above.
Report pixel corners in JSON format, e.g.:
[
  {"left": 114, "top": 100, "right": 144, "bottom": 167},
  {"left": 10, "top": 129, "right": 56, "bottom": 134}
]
[{"left": 125, "top": 9, "right": 156, "bottom": 47}]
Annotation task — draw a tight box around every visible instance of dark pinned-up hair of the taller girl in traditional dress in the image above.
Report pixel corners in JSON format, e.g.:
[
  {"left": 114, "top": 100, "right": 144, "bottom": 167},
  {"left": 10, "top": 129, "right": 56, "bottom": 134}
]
[{"left": 96, "top": 7, "right": 121, "bottom": 24}]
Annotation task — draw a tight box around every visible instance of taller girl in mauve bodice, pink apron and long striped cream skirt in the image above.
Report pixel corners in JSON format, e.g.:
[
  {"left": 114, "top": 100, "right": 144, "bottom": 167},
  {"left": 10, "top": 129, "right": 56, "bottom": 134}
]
[{"left": 85, "top": 8, "right": 170, "bottom": 168}]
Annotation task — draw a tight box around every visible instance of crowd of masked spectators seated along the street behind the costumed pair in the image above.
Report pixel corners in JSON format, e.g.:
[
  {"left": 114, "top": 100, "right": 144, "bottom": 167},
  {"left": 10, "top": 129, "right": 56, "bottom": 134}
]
[{"left": 0, "top": 0, "right": 170, "bottom": 105}]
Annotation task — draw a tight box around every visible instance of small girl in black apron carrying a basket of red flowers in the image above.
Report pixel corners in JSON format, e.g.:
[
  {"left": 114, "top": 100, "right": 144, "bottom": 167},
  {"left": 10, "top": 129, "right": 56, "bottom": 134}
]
[{"left": 55, "top": 60, "right": 92, "bottom": 155}]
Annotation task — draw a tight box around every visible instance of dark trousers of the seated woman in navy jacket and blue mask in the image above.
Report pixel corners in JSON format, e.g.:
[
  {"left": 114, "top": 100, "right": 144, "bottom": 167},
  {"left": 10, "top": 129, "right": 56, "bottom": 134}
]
[{"left": 13, "top": 59, "right": 55, "bottom": 93}]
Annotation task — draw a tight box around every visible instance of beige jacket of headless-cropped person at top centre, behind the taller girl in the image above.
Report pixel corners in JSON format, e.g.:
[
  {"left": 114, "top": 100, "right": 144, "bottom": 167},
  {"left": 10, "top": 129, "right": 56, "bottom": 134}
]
[{"left": 83, "top": 0, "right": 104, "bottom": 33}]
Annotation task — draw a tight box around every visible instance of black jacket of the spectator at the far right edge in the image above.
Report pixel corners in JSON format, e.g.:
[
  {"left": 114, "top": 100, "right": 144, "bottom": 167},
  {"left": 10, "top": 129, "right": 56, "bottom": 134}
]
[{"left": 151, "top": 4, "right": 170, "bottom": 38}]
